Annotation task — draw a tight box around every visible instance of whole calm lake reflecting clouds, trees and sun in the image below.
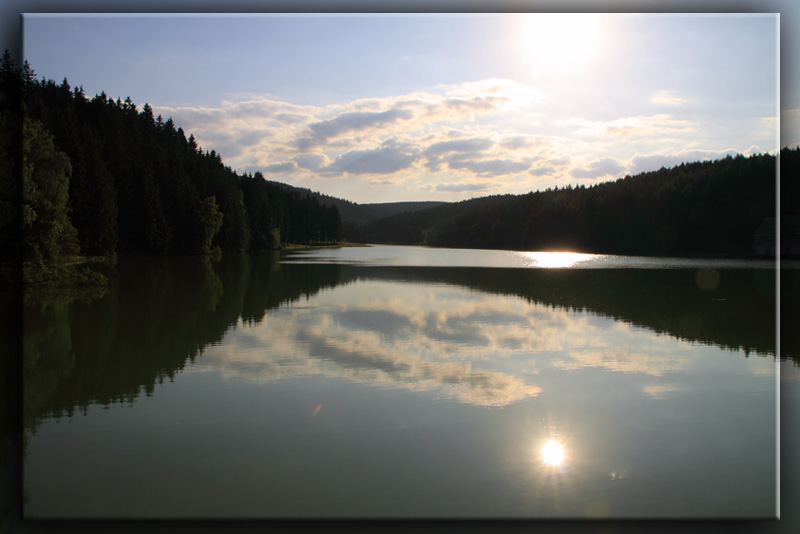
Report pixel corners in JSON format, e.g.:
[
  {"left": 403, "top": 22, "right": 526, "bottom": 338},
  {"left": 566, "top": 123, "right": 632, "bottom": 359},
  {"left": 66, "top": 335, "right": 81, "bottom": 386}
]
[{"left": 23, "top": 246, "right": 798, "bottom": 519}]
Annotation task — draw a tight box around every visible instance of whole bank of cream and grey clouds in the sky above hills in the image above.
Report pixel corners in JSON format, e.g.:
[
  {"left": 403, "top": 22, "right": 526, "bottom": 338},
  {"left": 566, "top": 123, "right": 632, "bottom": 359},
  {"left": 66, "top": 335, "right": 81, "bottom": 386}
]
[{"left": 156, "top": 79, "right": 768, "bottom": 202}]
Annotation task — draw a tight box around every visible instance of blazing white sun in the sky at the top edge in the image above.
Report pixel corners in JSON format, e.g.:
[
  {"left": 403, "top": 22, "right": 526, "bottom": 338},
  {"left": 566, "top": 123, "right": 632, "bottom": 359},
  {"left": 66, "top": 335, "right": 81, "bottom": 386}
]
[{"left": 520, "top": 13, "right": 605, "bottom": 72}]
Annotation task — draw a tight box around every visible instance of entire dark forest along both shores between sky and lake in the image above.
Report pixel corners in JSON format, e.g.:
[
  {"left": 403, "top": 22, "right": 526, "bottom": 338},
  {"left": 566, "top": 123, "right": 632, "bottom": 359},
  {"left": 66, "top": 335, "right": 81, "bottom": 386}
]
[{"left": 0, "top": 52, "right": 800, "bottom": 263}]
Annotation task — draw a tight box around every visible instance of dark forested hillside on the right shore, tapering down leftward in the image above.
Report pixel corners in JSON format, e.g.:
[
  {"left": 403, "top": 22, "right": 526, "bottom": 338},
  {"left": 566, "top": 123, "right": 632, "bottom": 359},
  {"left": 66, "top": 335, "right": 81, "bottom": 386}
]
[{"left": 364, "top": 149, "right": 800, "bottom": 256}]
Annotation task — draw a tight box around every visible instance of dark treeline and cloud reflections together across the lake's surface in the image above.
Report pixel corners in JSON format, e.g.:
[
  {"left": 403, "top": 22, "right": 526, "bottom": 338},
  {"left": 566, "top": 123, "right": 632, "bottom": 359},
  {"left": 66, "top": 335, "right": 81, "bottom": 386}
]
[{"left": 24, "top": 251, "right": 792, "bottom": 432}]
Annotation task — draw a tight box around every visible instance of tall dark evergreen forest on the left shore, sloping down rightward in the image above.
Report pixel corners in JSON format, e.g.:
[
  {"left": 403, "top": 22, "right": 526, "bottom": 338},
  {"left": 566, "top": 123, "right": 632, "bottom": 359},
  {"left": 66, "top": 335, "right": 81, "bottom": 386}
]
[{"left": 0, "top": 52, "right": 342, "bottom": 263}]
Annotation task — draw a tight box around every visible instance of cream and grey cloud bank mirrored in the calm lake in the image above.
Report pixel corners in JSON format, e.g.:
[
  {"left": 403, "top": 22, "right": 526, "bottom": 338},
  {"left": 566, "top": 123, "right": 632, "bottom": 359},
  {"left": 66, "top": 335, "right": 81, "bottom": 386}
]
[{"left": 188, "top": 280, "right": 700, "bottom": 407}]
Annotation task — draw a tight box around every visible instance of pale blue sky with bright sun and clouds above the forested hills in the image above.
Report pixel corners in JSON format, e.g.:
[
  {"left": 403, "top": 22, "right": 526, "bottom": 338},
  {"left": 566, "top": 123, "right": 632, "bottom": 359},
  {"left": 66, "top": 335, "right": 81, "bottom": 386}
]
[{"left": 14, "top": 13, "right": 788, "bottom": 203}]
